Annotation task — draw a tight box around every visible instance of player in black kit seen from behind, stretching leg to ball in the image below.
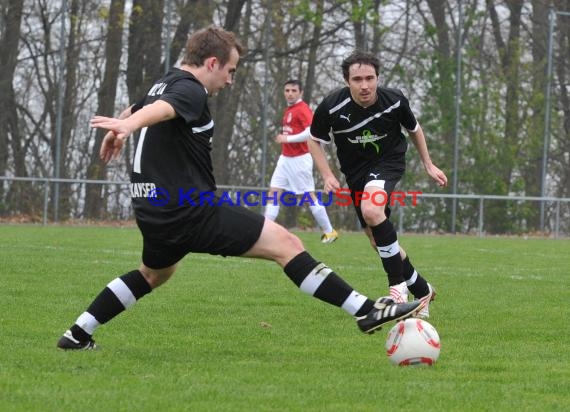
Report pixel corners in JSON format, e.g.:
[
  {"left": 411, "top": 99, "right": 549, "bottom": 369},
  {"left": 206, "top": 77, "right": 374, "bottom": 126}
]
[{"left": 57, "top": 26, "right": 424, "bottom": 350}]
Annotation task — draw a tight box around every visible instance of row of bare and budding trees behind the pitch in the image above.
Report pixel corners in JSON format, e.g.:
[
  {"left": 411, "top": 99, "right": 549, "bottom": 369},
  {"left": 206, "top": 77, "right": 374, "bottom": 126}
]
[{"left": 0, "top": 0, "right": 570, "bottom": 233}]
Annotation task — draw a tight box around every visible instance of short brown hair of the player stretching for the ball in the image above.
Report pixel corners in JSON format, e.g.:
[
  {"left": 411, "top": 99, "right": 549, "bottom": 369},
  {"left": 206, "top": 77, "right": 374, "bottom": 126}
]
[{"left": 182, "top": 25, "right": 244, "bottom": 67}]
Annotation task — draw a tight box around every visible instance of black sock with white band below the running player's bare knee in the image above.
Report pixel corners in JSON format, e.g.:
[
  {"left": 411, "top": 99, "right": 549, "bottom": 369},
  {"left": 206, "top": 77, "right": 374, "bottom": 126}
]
[{"left": 371, "top": 219, "right": 404, "bottom": 286}]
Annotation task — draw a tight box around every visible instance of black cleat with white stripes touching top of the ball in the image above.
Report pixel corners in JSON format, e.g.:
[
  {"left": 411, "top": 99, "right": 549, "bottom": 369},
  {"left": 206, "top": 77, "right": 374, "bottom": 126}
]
[{"left": 356, "top": 297, "right": 426, "bottom": 334}]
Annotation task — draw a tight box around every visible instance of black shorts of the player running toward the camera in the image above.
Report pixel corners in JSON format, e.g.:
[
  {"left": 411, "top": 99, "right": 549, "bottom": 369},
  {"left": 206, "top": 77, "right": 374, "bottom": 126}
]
[{"left": 347, "top": 159, "right": 405, "bottom": 228}]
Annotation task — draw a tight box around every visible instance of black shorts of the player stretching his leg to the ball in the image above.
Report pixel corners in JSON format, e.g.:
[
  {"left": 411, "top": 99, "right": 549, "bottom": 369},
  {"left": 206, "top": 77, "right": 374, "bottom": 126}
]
[{"left": 141, "top": 204, "right": 265, "bottom": 269}]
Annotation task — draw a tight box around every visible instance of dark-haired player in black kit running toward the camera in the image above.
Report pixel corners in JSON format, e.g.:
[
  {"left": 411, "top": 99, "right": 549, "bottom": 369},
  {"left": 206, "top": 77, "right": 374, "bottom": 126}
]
[{"left": 309, "top": 51, "right": 447, "bottom": 318}]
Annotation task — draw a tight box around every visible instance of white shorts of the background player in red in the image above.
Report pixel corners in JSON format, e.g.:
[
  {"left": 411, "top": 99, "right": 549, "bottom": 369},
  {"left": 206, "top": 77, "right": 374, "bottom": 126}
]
[{"left": 270, "top": 153, "right": 315, "bottom": 195}]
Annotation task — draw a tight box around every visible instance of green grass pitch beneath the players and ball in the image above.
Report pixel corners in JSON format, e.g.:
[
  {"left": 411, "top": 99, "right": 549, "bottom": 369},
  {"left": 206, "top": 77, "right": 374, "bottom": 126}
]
[{"left": 0, "top": 226, "right": 570, "bottom": 412}]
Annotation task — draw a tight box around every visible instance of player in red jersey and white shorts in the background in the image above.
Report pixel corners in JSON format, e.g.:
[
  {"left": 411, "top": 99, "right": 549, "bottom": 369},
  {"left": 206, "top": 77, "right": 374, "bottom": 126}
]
[{"left": 265, "top": 79, "right": 338, "bottom": 243}]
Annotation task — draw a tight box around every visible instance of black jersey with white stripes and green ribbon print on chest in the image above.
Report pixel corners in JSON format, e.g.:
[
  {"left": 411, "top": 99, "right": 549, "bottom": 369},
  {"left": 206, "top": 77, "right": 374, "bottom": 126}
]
[{"left": 311, "top": 87, "right": 418, "bottom": 180}]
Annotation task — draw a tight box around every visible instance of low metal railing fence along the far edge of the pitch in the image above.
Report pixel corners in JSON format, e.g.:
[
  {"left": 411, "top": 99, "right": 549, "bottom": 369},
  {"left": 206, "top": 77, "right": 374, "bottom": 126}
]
[{"left": 0, "top": 176, "right": 570, "bottom": 238}]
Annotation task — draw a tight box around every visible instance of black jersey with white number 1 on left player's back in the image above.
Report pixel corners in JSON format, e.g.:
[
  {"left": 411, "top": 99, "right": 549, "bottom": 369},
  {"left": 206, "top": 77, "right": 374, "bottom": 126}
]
[{"left": 131, "top": 68, "right": 216, "bottom": 230}]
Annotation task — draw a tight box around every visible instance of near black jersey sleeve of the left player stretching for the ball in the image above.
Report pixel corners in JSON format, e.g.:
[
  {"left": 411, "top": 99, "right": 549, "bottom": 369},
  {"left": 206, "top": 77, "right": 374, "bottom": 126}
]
[{"left": 160, "top": 78, "right": 208, "bottom": 123}]
